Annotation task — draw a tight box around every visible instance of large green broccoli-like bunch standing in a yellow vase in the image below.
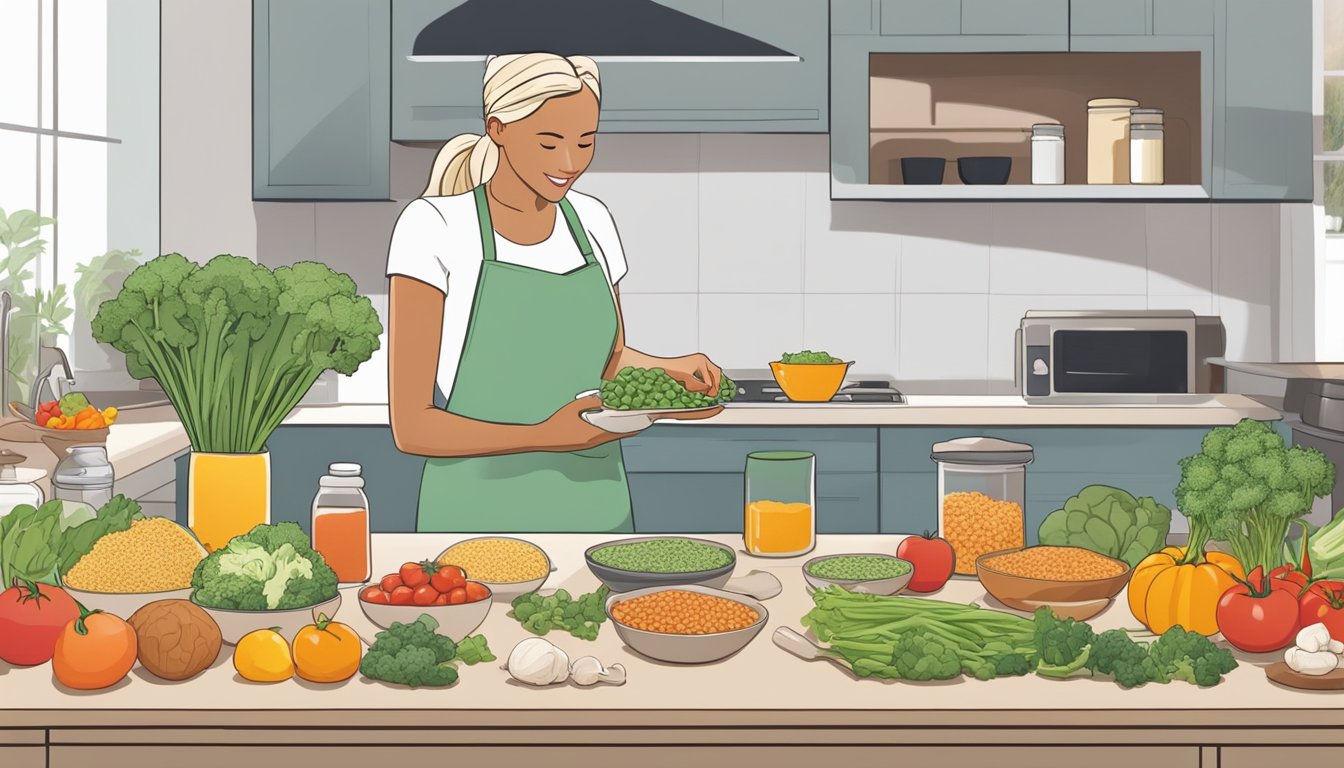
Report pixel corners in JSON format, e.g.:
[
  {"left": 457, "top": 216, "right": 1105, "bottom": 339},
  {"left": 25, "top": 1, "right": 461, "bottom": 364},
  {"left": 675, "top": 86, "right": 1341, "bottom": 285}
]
[{"left": 93, "top": 253, "right": 383, "bottom": 550}]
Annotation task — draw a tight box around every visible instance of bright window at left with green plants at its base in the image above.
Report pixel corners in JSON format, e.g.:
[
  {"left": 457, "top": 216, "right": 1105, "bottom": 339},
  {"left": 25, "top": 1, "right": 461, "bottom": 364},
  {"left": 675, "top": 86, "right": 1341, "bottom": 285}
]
[{"left": 0, "top": 0, "right": 159, "bottom": 402}]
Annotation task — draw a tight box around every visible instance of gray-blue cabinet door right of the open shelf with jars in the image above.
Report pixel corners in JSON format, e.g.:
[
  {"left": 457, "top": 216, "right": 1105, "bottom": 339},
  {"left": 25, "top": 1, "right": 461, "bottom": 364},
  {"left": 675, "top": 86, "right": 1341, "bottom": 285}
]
[{"left": 1212, "top": 0, "right": 1314, "bottom": 202}]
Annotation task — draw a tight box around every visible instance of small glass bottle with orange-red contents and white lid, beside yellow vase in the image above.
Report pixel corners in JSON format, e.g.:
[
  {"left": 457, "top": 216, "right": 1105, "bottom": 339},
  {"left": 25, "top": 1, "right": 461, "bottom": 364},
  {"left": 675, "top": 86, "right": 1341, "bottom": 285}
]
[{"left": 312, "top": 463, "right": 372, "bottom": 584}]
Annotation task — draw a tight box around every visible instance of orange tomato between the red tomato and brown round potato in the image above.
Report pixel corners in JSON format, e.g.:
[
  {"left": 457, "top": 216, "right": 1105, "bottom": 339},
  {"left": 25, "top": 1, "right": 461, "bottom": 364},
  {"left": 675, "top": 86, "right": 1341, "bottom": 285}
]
[{"left": 51, "top": 605, "right": 137, "bottom": 690}]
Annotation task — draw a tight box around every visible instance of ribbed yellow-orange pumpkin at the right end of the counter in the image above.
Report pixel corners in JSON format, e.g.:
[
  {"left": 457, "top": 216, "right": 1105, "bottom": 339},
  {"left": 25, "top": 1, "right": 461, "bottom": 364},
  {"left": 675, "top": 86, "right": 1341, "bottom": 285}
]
[{"left": 1129, "top": 546, "right": 1246, "bottom": 635}]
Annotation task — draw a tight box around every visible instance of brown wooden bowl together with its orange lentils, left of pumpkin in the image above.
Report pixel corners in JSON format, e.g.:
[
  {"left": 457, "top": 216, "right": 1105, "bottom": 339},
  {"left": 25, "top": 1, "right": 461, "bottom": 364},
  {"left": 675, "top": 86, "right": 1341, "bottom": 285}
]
[{"left": 976, "top": 546, "right": 1133, "bottom": 620}]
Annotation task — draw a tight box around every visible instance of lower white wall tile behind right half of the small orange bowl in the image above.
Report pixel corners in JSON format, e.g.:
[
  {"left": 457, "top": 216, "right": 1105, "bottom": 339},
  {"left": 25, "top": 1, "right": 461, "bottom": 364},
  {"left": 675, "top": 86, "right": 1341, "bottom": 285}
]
[{"left": 801, "top": 293, "right": 900, "bottom": 377}]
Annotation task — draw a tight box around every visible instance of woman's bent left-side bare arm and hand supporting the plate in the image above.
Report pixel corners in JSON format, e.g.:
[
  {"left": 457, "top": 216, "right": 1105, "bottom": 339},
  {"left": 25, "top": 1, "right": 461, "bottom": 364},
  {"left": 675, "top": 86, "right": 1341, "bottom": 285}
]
[{"left": 387, "top": 276, "right": 613, "bottom": 457}]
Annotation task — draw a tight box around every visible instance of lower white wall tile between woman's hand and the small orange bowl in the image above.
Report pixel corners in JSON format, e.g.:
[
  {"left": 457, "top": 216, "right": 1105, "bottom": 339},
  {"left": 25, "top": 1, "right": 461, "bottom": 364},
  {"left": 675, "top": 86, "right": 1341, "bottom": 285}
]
[{"left": 700, "top": 293, "right": 804, "bottom": 369}]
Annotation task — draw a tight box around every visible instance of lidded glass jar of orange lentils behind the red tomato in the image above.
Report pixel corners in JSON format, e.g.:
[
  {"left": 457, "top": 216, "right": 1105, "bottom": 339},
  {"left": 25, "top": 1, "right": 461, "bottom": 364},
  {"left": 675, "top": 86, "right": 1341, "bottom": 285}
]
[{"left": 931, "top": 437, "right": 1034, "bottom": 576}]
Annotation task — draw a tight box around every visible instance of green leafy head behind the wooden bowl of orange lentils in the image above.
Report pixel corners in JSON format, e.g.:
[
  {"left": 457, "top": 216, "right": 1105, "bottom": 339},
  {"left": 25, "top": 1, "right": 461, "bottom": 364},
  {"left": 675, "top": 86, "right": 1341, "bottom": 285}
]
[{"left": 1038, "top": 486, "right": 1172, "bottom": 566}]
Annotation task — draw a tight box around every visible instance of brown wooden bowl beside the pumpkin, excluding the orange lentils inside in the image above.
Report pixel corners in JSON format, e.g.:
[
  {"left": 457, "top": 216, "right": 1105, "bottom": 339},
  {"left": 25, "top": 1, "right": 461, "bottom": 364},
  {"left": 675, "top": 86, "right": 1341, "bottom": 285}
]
[{"left": 976, "top": 547, "right": 1133, "bottom": 620}]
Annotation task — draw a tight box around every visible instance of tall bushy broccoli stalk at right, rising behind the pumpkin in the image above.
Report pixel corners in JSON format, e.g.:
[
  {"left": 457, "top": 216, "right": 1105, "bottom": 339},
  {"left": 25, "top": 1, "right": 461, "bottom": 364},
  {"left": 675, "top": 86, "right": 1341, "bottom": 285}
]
[{"left": 1176, "top": 418, "right": 1335, "bottom": 572}]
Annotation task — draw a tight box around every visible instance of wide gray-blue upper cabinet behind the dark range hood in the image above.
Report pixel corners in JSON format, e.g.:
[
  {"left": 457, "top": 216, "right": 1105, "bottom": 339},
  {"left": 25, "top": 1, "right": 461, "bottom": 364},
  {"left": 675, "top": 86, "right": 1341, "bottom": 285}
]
[{"left": 391, "top": 0, "right": 828, "bottom": 141}]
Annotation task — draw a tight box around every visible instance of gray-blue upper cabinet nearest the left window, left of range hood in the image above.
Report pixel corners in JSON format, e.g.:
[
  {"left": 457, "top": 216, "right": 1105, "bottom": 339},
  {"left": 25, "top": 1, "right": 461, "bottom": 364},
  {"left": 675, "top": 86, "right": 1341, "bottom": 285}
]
[{"left": 253, "top": 0, "right": 391, "bottom": 200}]
